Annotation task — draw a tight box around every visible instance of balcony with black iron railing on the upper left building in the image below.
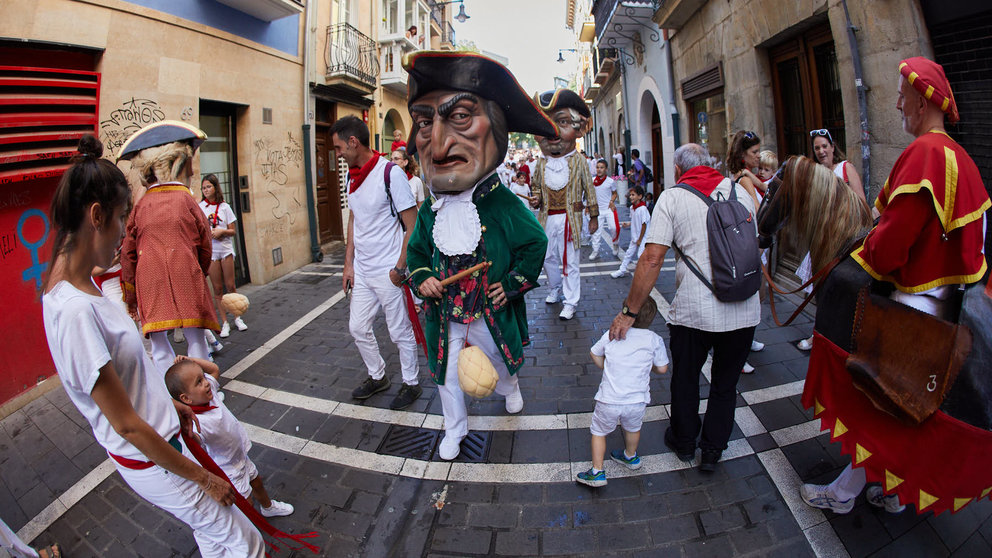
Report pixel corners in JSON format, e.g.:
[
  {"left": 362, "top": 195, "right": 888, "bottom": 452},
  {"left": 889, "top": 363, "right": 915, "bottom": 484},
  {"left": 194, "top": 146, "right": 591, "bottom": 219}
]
[{"left": 324, "top": 23, "right": 379, "bottom": 94}]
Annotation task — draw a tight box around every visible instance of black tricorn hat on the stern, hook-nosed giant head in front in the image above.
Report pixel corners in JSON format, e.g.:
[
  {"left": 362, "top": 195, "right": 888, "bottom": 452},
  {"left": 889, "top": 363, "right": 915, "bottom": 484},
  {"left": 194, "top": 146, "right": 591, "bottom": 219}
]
[{"left": 403, "top": 50, "right": 560, "bottom": 154}]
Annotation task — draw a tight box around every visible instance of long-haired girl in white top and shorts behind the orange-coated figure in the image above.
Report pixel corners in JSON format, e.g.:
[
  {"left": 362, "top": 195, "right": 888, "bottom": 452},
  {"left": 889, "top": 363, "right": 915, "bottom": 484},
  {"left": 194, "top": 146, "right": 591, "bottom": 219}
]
[{"left": 200, "top": 174, "right": 248, "bottom": 337}]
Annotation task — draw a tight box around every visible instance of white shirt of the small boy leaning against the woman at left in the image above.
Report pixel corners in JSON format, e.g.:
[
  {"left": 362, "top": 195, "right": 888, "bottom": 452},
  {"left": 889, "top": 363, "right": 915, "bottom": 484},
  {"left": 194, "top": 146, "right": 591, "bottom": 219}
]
[{"left": 196, "top": 374, "right": 251, "bottom": 494}]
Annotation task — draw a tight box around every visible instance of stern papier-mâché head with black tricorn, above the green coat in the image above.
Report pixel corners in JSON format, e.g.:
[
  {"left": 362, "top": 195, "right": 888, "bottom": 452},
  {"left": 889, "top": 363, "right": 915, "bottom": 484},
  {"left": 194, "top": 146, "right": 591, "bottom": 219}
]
[{"left": 403, "top": 51, "right": 557, "bottom": 194}]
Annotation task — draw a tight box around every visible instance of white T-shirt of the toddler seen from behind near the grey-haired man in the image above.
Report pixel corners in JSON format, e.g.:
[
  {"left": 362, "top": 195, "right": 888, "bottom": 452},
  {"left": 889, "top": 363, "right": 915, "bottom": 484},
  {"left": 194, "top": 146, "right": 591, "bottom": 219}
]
[{"left": 589, "top": 327, "right": 668, "bottom": 405}]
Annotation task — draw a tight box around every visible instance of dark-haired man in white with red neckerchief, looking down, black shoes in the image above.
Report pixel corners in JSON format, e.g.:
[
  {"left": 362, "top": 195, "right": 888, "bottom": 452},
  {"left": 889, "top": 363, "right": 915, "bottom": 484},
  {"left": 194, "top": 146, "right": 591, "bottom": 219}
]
[{"left": 331, "top": 116, "right": 421, "bottom": 409}]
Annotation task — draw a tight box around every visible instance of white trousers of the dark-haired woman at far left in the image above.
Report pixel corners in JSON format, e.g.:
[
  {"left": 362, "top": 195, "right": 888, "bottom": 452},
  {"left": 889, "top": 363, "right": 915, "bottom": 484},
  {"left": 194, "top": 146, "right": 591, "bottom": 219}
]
[{"left": 117, "top": 444, "right": 265, "bottom": 558}]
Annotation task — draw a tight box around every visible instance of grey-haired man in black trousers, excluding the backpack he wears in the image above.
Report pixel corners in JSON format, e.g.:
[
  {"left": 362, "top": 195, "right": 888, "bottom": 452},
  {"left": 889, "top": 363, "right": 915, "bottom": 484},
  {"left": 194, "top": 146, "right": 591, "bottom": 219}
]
[{"left": 610, "top": 143, "right": 761, "bottom": 472}]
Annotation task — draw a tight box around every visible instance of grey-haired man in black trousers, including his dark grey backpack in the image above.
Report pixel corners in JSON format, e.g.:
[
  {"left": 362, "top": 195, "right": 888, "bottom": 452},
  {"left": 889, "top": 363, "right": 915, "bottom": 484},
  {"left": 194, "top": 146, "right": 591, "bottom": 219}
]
[{"left": 610, "top": 143, "right": 761, "bottom": 472}]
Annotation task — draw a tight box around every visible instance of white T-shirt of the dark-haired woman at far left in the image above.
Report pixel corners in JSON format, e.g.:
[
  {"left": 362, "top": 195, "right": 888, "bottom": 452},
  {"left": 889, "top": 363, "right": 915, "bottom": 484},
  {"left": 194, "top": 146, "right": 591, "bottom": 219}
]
[{"left": 41, "top": 281, "right": 179, "bottom": 461}]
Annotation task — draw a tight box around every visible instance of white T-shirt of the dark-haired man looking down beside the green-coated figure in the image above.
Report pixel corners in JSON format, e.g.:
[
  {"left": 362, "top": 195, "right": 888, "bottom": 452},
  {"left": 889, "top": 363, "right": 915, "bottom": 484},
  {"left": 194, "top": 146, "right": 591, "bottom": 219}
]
[{"left": 348, "top": 159, "right": 417, "bottom": 277}]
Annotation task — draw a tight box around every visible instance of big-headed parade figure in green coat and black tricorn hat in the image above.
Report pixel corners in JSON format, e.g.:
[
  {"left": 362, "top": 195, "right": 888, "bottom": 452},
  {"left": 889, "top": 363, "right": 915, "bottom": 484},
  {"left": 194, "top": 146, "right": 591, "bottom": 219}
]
[{"left": 403, "top": 51, "right": 557, "bottom": 460}]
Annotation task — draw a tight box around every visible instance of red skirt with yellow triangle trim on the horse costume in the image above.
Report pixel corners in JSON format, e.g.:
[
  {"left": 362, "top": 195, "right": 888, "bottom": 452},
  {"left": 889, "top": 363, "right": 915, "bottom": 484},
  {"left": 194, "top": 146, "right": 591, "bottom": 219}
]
[{"left": 802, "top": 332, "right": 992, "bottom": 514}]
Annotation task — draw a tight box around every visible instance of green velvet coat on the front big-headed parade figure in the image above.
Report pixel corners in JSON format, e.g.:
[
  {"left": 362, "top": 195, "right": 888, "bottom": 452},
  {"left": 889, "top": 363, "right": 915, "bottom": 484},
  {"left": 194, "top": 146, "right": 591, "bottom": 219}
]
[{"left": 407, "top": 173, "right": 548, "bottom": 385}]
